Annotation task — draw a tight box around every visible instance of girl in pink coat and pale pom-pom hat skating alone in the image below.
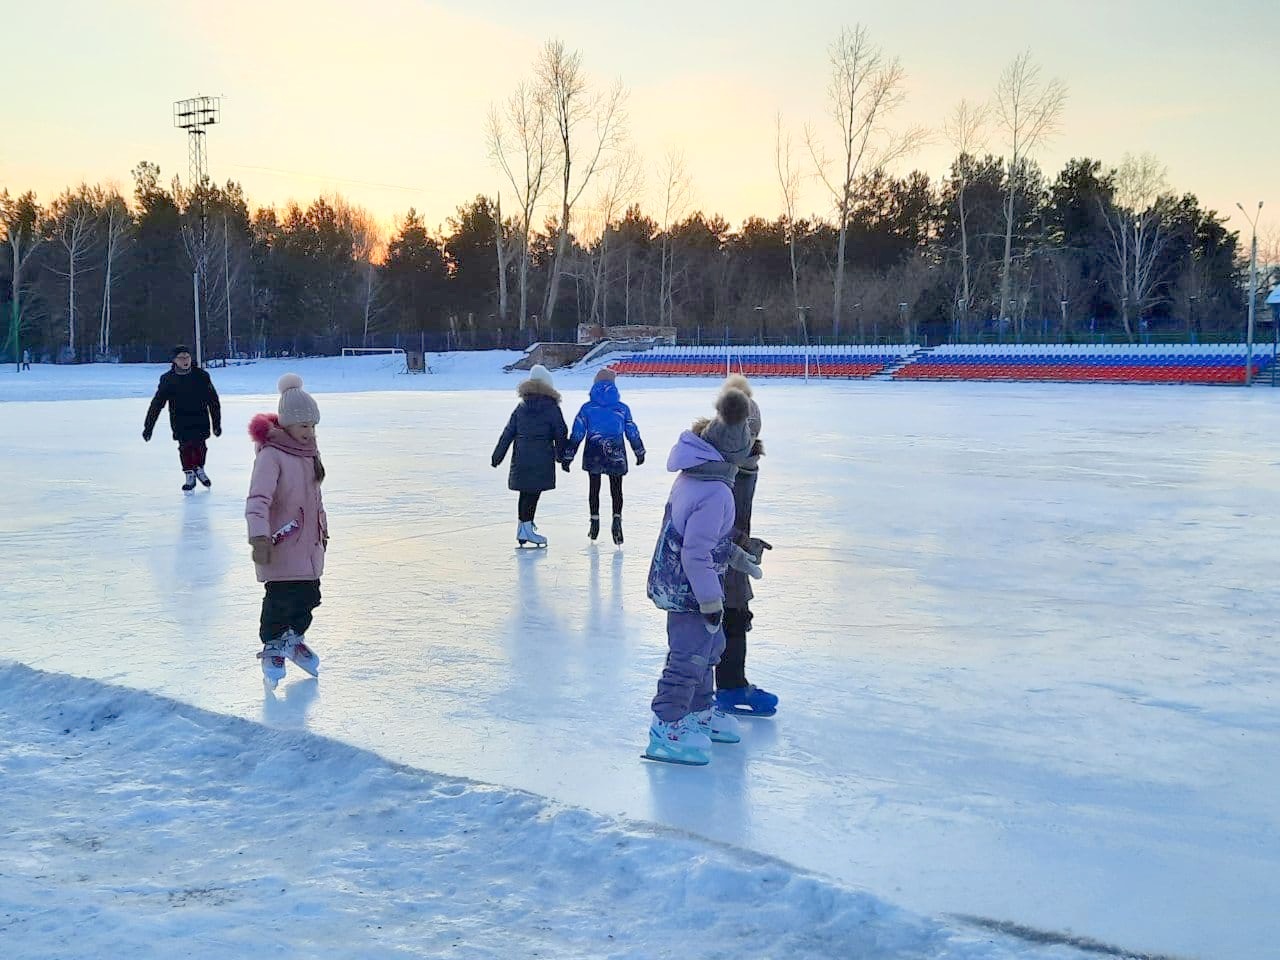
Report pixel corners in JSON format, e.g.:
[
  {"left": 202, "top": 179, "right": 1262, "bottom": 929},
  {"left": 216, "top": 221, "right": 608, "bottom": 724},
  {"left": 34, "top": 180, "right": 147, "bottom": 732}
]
[{"left": 244, "top": 374, "right": 329, "bottom": 690}]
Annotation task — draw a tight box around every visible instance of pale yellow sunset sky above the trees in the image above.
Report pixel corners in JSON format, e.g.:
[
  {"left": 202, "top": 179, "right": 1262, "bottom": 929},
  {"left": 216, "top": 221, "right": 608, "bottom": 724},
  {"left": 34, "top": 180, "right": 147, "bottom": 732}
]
[{"left": 0, "top": 0, "right": 1280, "bottom": 244}]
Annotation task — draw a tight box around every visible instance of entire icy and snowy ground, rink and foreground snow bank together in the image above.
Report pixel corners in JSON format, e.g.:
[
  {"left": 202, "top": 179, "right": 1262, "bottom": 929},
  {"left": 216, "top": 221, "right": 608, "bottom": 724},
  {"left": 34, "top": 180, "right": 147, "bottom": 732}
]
[{"left": 0, "top": 355, "right": 1280, "bottom": 960}]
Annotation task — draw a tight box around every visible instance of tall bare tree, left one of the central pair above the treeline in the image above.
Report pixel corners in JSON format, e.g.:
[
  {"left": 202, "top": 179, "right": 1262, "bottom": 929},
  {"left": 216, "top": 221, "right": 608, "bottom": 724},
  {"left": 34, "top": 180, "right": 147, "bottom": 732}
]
[{"left": 488, "top": 83, "right": 556, "bottom": 330}]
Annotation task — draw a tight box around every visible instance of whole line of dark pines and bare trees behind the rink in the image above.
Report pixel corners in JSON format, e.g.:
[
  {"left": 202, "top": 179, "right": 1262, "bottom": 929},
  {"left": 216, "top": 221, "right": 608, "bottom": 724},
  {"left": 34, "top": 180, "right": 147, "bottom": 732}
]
[{"left": 0, "top": 27, "right": 1280, "bottom": 360}]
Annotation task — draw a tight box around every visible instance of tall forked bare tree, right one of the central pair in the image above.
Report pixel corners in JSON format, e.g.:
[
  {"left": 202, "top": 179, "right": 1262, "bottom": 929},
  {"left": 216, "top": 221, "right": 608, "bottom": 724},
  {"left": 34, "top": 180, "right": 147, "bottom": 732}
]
[{"left": 538, "top": 40, "right": 626, "bottom": 326}]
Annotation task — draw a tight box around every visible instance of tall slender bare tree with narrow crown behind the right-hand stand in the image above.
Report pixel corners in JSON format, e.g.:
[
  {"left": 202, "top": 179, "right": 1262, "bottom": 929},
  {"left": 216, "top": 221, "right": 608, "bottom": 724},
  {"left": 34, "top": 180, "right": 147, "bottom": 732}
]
[{"left": 995, "top": 51, "right": 1066, "bottom": 335}]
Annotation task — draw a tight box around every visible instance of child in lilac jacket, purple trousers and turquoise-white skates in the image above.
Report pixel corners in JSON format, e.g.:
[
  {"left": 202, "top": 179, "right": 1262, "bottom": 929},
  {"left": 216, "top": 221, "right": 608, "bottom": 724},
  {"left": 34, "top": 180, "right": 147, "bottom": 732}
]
[{"left": 645, "top": 389, "right": 762, "bottom": 765}]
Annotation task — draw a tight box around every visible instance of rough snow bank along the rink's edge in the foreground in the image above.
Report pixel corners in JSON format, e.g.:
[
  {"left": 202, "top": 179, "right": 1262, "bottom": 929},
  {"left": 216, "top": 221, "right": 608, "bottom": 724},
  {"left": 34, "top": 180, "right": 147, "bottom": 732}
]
[{"left": 0, "top": 664, "right": 1079, "bottom": 960}]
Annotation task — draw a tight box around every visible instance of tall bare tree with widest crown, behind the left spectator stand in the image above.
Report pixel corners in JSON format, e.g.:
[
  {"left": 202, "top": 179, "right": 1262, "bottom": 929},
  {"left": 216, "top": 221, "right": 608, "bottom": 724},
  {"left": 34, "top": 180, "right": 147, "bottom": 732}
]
[{"left": 805, "top": 24, "right": 927, "bottom": 337}]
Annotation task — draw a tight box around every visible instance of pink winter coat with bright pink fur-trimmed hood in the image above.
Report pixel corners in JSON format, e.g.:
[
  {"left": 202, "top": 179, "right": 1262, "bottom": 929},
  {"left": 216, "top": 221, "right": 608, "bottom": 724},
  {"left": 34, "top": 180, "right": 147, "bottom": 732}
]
[{"left": 244, "top": 413, "right": 329, "bottom": 584}]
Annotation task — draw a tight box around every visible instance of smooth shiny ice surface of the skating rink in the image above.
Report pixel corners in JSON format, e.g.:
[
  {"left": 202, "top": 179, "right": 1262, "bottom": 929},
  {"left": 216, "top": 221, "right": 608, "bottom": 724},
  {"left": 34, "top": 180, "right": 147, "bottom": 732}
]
[{"left": 0, "top": 366, "right": 1280, "bottom": 960}]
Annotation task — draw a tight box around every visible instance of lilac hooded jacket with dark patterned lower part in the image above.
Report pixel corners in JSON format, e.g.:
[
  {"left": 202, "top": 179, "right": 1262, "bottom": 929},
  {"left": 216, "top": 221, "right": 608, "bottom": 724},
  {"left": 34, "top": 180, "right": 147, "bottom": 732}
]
[{"left": 648, "top": 430, "right": 737, "bottom": 613}]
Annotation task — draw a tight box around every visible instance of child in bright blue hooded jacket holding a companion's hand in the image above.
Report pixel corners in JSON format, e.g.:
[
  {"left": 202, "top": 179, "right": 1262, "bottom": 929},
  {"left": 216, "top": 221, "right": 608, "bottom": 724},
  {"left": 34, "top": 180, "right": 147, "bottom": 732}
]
[{"left": 561, "top": 367, "right": 644, "bottom": 544}]
